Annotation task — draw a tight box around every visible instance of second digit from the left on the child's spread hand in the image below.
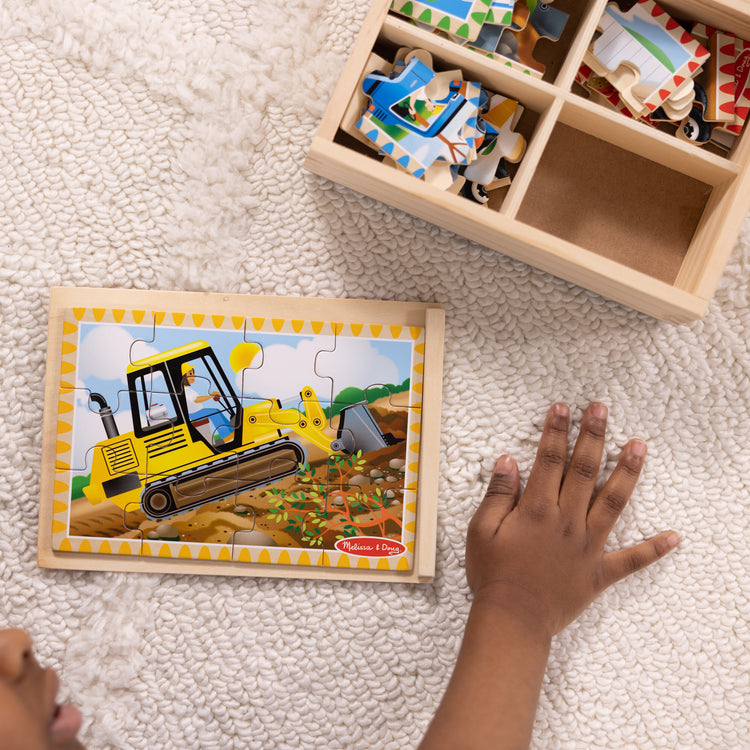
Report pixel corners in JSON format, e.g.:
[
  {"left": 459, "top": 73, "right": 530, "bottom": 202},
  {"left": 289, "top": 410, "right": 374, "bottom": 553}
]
[{"left": 521, "top": 404, "right": 570, "bottom": 513}]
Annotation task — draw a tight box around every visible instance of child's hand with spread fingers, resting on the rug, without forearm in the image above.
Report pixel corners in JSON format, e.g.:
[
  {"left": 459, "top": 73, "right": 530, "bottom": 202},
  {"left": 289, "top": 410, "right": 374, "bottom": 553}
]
[{"left": 466, "top": 404, "right": 679, "bottom": 637}]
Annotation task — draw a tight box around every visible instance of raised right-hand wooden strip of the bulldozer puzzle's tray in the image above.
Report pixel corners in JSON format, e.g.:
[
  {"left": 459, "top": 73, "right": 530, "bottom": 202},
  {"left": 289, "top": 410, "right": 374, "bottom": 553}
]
[{"left": 414, "top": 308, "right": 445, "bottom": 580}]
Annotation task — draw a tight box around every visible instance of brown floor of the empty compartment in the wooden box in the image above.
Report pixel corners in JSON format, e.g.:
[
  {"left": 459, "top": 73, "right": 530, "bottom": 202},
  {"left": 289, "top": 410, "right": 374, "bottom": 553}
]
[{"left": 517, "top": 123, "right": 713, "bottom": 284}]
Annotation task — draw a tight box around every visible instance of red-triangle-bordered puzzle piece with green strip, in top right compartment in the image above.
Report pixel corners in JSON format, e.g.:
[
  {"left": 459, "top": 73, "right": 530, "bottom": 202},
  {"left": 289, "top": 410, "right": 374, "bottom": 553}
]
[{"left": 584, "top": 0, "right": 709, "bottom": 117}]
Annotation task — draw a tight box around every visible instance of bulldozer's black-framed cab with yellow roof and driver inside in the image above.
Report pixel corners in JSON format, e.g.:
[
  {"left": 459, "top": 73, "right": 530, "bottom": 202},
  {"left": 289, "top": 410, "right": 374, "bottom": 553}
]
[{"left": 128, "top": 342, "right": 242, "bottom": 453}]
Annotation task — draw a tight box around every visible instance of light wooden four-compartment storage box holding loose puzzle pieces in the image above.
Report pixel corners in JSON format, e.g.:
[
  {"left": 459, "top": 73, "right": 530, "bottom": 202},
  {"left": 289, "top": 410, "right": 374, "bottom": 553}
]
[{"left": 305, "top": 0, "right": 750, "bottom": 323}]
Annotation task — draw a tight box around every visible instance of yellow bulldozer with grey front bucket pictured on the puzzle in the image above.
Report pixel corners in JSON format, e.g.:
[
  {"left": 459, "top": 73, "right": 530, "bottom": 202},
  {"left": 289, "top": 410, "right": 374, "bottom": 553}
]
[{"left": 84, "top": 341, "right": 396, "bottom": 519}]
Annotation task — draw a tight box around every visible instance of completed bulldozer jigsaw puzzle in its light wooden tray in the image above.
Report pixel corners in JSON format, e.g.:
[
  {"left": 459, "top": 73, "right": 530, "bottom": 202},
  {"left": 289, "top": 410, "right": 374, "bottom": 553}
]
[{"left": 39, "top": 289, "right": 443, "bottom": 581}]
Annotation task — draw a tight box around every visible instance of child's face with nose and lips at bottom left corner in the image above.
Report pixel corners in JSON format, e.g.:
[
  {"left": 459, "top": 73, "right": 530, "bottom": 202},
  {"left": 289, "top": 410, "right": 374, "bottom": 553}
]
[{"left": 0, "top": 630, "right": 83, "bottom": 750}]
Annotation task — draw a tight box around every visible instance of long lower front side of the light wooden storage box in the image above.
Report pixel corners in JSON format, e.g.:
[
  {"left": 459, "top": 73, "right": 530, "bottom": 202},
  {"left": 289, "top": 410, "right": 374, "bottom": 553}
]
[{"left": 306, "top": 139, "right": 707, "bottom": 322}]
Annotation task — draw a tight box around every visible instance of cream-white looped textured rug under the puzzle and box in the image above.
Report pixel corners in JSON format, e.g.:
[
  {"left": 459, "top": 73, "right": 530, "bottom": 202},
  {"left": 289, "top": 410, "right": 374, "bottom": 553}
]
[{"left": 0, "top": 0, "right": 750, "bottom": 750}]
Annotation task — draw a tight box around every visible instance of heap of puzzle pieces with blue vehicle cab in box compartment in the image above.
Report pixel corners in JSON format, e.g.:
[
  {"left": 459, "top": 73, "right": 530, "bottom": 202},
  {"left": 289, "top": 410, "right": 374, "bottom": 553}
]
[{"left": 352, "top": 49, "right": 526, "bottom": 203}]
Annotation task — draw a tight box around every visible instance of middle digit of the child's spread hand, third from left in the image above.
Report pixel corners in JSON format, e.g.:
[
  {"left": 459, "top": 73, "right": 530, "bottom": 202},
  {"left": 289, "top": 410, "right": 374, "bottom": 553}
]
[{"left": 560, "top": 403, "right": 607, "bottom": 521}]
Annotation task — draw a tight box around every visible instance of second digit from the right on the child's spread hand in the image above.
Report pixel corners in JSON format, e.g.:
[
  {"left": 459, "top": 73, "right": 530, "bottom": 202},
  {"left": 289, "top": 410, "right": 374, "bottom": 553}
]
[{"left": 586, "top": 440, "right": 646, "bottom": 547}]
